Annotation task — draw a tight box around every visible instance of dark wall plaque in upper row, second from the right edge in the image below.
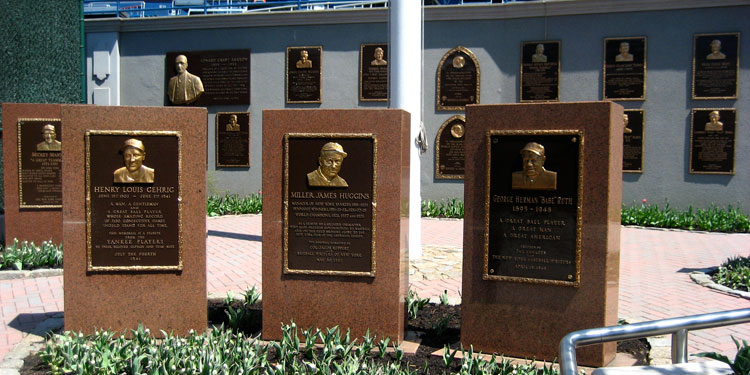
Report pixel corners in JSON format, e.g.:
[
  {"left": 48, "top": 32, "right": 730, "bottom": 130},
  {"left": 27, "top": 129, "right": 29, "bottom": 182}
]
[{"left": 602, "top": 36, "right": 646, "bottom": 100}]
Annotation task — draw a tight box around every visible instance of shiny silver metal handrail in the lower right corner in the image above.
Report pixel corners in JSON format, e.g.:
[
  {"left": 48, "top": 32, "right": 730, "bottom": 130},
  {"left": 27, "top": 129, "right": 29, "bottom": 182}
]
[{"left": 560, "top": 309, "right": 750, "bottom": 375}]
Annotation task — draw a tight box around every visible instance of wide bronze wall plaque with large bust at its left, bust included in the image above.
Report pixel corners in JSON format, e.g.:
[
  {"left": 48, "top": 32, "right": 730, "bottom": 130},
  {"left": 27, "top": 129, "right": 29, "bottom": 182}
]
[{"left": 164, "top": 49, "right": 250, "bottom": 107}]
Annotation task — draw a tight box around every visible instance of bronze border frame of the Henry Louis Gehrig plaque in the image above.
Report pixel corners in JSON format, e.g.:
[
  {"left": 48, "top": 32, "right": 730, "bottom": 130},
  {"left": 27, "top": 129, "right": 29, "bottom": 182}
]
[{"left": 84, "top": 130, "right": 185, "bottom": 272}]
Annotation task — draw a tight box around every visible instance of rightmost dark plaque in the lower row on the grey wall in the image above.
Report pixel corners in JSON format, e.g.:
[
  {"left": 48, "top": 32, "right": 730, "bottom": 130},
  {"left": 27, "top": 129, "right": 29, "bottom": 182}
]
[{"left": 690, "top": 108, "right": 737, "bottom": 174}]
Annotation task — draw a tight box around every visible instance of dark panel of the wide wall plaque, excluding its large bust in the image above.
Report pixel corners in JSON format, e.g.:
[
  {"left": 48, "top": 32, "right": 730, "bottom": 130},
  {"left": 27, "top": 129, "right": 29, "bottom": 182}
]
[{"left": 164, "top": 49, "right": 250, "bottom": 107}]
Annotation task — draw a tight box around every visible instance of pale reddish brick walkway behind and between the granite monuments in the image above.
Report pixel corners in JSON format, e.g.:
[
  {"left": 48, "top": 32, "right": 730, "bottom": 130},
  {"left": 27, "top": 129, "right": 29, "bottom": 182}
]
[{"left": 0, "top": 215, "right": 750, "bottom": 361}]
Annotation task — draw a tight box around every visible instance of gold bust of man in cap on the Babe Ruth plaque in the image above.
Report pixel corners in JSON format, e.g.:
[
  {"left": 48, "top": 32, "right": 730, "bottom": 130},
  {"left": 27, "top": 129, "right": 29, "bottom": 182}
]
[{"left": 512, "top": 142, "right": 557, "bottom": 190}]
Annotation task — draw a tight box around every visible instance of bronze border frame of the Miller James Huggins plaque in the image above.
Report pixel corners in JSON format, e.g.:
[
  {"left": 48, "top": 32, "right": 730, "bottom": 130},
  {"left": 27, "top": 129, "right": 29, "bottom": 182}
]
[{"left": 281, "top": 132, "right": 378, "bottom": 278}]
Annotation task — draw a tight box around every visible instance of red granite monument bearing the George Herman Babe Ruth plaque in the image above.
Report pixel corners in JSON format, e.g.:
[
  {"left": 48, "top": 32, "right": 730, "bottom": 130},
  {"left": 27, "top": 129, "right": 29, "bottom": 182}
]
[{"left": 461, "top": 102, "right": 623, "bottom": 366}]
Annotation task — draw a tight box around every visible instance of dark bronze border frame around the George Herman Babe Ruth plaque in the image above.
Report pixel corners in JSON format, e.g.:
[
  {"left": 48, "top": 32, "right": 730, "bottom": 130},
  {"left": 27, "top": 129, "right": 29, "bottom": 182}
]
[{"left": 482, "top": 129, "right": 585, "bottom": 288}]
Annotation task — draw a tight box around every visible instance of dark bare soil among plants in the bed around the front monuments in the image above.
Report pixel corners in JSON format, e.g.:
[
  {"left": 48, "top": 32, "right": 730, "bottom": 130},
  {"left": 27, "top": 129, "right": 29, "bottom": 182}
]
[{"left": 20, "top": 302, "right": 651, "bottom": 375}]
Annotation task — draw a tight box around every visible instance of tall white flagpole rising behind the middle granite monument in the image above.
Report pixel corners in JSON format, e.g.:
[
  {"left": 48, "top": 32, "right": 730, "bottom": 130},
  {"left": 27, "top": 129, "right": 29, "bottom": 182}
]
[{"left": 388, "top": 0, "right": 422, "bottom": 259}]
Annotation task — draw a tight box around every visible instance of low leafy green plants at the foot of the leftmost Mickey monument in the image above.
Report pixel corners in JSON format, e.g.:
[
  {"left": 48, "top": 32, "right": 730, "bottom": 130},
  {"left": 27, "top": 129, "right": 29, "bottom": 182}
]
[{"left": 0, "top": 239, "right": 63, "bottom": 270}]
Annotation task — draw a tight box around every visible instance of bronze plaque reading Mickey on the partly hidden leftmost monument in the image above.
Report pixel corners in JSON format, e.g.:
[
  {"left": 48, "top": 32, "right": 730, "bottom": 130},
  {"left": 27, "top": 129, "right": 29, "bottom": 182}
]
[{"left": 18, "top": 118, "right": 62, "bottom": 209}]
